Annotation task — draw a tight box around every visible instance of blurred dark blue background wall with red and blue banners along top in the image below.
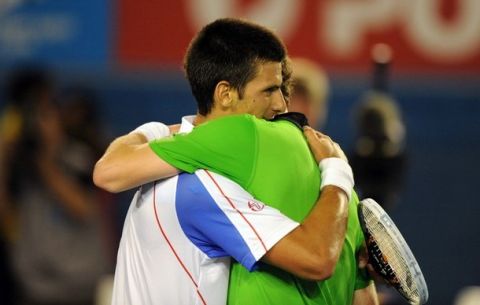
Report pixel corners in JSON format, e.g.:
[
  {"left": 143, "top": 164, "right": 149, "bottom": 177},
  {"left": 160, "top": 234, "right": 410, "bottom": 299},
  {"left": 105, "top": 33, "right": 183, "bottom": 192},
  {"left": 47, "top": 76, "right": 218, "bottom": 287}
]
[{"left": 0, "top": 0, "right": 480, "bottom": 305}]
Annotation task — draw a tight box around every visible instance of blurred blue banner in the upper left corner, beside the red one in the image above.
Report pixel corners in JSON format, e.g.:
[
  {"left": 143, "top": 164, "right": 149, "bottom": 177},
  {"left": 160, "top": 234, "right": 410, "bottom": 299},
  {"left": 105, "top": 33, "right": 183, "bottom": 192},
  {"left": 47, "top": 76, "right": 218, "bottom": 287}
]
[{"left": 0, "top": 0, "right": 111, "bottom": 66}]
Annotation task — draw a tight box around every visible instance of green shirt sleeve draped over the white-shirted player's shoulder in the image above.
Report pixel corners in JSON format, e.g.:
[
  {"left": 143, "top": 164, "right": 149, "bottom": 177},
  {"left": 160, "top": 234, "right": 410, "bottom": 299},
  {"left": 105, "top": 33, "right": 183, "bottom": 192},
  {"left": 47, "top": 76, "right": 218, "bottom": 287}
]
[{"left": 149, "top": 115, "right": 257, "bottom": 188}]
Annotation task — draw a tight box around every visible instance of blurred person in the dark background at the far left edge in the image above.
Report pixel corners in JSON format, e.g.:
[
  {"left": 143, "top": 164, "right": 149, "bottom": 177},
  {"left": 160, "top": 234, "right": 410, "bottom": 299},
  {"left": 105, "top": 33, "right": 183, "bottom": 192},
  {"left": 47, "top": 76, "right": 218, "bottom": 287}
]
[{"left": 0, "top": 67, "right": 107, "bottom": 305}]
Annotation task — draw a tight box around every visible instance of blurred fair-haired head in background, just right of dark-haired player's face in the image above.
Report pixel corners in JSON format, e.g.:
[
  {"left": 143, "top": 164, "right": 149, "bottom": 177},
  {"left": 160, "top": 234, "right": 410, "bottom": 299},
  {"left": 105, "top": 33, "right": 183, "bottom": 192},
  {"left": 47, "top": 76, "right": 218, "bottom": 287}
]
[{"left": 288, "top": 58, "right": 330, "bottom": 128}]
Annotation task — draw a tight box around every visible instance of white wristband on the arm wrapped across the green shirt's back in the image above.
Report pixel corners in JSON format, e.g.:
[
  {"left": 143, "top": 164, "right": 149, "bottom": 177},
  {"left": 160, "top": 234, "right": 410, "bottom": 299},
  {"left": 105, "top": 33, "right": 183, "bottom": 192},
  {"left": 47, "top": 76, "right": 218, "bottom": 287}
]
[{"left": 318, "top": 158, "right": 355, "bottom": 200}]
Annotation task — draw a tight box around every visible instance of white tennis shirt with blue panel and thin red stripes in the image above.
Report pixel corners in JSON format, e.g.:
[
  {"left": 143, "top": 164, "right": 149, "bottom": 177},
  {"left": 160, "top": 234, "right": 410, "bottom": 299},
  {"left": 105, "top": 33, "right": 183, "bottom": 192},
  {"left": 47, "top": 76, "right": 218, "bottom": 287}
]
[{"left": 112, "top": 117, "right": 298, "bottom": 305}]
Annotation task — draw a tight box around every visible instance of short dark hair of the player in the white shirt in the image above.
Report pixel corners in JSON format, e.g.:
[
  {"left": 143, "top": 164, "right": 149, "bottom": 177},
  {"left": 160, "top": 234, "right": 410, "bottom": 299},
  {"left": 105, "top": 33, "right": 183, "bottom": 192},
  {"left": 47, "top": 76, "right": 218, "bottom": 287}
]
[{"left": 184, "top": 18, "right": 287, "bottom": 115}]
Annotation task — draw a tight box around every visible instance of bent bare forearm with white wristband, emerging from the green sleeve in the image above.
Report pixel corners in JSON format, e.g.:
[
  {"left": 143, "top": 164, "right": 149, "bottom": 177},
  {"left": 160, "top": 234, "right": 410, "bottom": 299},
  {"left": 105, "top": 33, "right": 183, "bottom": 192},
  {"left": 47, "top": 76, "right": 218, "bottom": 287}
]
[{"left": 93, "top": 122, "right": 178, "bottom": 193}]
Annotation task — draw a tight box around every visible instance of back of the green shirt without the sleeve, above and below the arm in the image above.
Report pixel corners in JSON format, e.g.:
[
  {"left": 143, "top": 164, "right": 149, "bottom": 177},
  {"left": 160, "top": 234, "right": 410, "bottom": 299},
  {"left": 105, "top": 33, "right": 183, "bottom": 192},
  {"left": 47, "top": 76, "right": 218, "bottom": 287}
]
[{"left": 228, "top": 115, "right": 361, "bottom": 304}]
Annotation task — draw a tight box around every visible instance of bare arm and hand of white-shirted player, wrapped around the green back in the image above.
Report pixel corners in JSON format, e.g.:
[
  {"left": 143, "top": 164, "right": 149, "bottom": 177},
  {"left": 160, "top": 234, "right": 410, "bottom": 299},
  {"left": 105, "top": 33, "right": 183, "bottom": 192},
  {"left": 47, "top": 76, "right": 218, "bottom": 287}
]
[{"left": 263, "top": 129, "right": 353, "bottom": 280}]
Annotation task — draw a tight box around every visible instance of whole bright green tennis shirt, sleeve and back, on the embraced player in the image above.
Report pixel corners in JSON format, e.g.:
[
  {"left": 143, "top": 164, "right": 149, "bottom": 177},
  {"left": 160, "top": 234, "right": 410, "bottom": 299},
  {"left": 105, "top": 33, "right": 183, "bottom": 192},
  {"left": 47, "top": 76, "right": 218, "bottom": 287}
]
[{"left": 150, "top": 115, "right": 368, "bottom": 305}]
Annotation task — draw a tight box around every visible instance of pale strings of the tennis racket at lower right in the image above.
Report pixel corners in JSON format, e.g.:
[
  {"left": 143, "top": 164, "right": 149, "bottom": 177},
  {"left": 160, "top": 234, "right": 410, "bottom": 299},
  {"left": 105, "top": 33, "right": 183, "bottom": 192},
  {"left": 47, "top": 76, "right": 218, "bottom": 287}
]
[{"left": 363, "top": 205, "right": 420, "bottom": 303}]
